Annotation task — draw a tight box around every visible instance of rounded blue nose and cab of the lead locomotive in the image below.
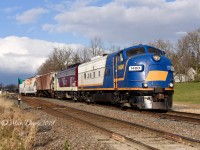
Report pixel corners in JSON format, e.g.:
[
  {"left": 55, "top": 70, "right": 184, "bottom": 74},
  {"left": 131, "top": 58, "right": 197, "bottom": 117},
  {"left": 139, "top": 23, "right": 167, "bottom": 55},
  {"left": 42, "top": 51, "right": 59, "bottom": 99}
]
[{"left": 114, "top": 45, "right": 174, "bottom": 110}]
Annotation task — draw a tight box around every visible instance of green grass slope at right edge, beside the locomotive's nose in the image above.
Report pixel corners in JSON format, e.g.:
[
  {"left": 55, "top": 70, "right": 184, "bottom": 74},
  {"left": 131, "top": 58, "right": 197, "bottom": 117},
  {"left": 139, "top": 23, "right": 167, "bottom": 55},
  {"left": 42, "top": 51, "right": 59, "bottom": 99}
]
[{"left": 174, "top": 82, "right": 200, "bottom": 104}]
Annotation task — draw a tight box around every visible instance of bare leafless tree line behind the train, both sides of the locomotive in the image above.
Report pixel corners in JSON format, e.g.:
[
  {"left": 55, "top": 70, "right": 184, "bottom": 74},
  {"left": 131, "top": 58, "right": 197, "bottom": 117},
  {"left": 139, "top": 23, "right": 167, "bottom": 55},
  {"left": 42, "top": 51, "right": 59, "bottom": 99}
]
[{"left": 37, "top": 28, "right": 200, "bottom": 81}]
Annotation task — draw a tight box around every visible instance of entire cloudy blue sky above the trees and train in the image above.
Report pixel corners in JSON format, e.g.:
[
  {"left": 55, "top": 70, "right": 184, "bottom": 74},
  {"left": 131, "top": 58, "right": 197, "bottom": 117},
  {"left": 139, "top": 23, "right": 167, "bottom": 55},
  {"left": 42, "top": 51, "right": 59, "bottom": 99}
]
[{"left": 0, "top": 0, "right": 200, "bottom": 84}]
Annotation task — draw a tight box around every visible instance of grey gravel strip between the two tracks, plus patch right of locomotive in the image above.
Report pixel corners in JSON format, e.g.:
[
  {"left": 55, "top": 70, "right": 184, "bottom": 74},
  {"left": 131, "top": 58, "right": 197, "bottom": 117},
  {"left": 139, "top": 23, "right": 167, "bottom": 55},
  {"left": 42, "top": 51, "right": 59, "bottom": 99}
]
[{"left": 38, "top": 99, "right": 200, "bottom": 139}]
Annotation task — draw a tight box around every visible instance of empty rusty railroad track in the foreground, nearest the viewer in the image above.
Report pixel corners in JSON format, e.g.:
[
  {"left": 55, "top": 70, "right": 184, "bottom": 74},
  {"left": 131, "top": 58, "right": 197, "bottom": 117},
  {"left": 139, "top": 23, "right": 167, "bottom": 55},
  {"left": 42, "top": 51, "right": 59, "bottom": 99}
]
[{"left": 23, "top": 98, "right": 200, "bottom": 149}]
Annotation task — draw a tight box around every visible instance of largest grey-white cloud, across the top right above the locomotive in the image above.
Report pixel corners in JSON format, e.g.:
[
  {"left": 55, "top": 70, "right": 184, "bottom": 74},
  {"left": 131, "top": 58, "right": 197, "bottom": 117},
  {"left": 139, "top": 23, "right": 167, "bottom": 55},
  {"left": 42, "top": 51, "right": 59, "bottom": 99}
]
[{"left": 43, "top": 0, "right": 200, "bottom": 43}]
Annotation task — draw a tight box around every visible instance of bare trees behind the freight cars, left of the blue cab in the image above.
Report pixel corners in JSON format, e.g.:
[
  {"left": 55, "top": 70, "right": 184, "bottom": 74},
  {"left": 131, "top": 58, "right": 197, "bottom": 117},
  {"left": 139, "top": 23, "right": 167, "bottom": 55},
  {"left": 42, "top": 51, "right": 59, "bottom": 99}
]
[{"left": 37, "top": 37, "right": 108, "bottom": 74}]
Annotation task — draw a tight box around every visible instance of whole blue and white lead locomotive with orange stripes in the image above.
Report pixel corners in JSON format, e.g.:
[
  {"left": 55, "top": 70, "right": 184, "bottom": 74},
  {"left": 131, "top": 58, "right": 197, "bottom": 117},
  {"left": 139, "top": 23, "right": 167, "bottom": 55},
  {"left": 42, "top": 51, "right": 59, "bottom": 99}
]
[{"left": 78, "top": 45, "right": 174, "bottom": 110}]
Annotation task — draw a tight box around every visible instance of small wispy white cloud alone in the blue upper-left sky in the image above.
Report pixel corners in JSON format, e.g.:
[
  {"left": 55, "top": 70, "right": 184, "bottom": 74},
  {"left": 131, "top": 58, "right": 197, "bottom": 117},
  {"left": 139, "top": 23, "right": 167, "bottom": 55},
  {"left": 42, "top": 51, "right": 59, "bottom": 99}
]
[{"left": 16, "top": 8, "right": 48, "bottom": 24}]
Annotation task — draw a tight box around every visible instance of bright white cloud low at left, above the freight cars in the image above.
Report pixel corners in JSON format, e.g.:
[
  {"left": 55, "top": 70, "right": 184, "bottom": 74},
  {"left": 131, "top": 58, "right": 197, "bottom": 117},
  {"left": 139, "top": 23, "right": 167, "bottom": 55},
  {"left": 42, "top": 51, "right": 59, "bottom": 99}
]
[{"left": 0, "top": 36, "right": 81, "bottom": 74}]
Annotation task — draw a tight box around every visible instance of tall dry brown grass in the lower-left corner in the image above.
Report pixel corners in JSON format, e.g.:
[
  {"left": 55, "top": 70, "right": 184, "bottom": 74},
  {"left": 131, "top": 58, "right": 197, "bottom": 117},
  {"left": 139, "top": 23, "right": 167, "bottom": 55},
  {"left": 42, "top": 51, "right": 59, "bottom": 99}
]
[{"left": 0, "top": 97, "right": 36, "bottom": 150}]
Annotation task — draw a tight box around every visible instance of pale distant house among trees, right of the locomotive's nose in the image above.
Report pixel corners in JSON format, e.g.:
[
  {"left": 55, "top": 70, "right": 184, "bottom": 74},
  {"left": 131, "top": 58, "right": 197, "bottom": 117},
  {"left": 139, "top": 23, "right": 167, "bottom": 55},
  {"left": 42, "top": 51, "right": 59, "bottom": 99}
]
[{"left": 174, "top": 67, "right": 197, "bottom": 82}]
